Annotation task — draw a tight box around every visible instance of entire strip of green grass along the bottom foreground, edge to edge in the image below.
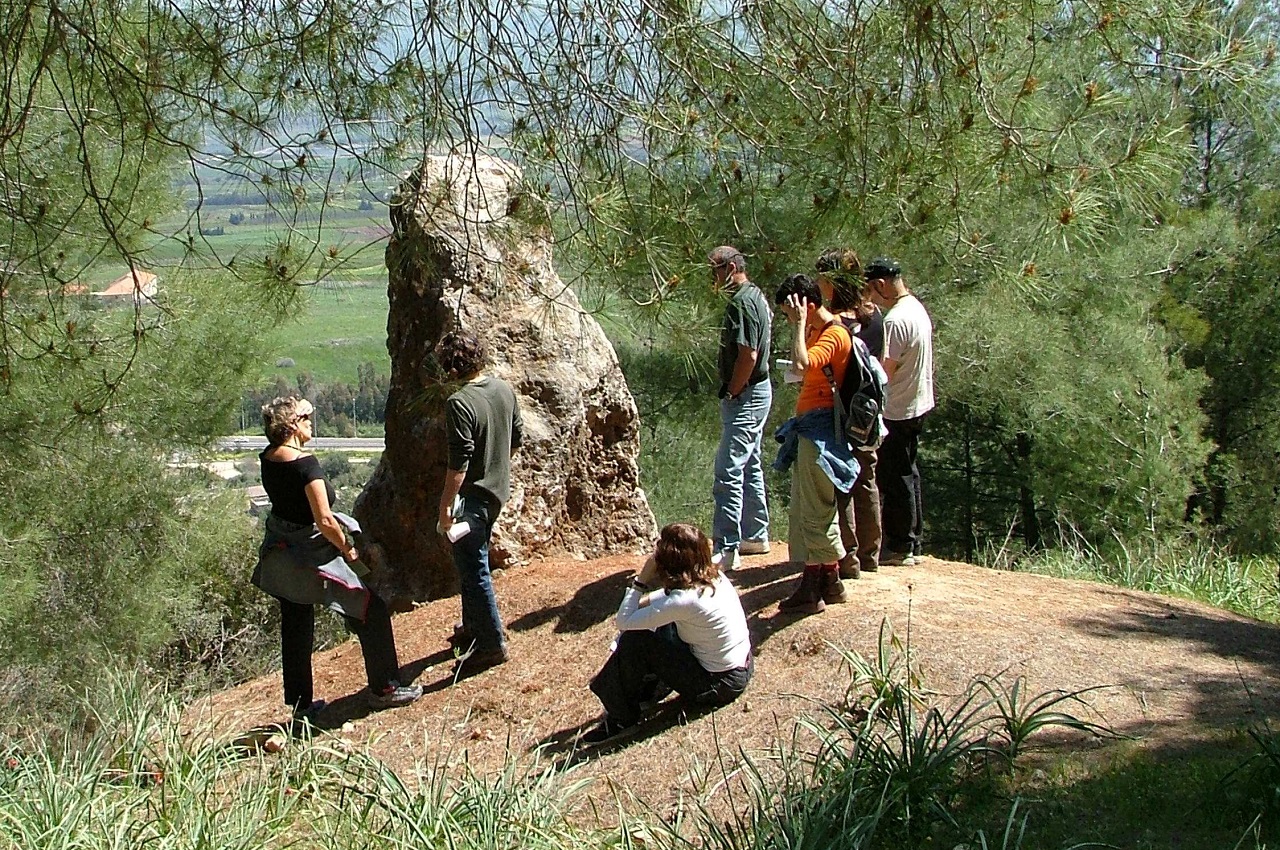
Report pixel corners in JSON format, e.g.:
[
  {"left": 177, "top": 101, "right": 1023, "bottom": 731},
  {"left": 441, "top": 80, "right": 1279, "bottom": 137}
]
[{"left": 10, "top": 627, "right": 1280, "bottom": 850}]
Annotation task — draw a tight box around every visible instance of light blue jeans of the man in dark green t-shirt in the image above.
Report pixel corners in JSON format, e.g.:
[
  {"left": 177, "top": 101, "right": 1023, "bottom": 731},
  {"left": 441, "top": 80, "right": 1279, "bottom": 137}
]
[{"left": 712, "top": 379, "right": 773, "bottom": 550}]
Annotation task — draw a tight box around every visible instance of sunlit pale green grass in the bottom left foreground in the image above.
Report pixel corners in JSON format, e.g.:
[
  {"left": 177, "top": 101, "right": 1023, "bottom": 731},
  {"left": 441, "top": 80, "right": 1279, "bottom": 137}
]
[{"left": 0, "top": 676, "right": 605, "bottom": 850}]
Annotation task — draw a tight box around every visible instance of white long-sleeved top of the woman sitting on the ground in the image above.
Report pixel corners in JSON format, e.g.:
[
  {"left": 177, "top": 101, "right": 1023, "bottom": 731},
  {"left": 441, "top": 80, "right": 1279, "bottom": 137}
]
[{"left": 617, "top": 576, "right": 751, "bottom": 673}]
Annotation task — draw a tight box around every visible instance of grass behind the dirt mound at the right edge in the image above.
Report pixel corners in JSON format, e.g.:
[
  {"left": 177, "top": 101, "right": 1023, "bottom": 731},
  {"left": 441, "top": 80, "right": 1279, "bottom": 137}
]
[{"left": 984, "top": 538, "right": 1280, "bottom": 622}]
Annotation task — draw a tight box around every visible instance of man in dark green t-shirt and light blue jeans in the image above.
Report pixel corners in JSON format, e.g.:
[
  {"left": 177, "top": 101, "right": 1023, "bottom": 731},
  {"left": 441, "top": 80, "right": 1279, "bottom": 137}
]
[{"left": 707, "top": 245, "right": 773, "bottom": 570}]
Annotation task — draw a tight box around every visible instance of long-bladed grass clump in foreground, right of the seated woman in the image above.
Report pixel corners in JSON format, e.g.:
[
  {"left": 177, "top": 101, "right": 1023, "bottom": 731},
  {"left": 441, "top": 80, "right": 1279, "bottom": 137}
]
[{"left": 655, "top": 621, "right": 1110, "bottom": 850}]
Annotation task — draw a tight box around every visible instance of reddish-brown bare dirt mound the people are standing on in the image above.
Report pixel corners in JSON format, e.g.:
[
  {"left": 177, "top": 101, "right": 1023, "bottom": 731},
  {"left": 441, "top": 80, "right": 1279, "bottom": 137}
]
[{"left": 188, "top": 544, "right": 1280, "bottom": 810}]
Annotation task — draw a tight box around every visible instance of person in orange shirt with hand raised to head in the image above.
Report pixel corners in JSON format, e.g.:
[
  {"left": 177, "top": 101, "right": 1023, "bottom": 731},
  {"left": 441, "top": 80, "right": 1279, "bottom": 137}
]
[{"left": 773, "top": 274, "right": 858, "bottom": 614}]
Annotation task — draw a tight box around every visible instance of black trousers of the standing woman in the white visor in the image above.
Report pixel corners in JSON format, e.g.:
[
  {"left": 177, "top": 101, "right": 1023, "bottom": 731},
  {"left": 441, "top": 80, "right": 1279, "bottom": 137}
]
[{"left": 276, "top": 593, "right": 399, "bottom": 710}]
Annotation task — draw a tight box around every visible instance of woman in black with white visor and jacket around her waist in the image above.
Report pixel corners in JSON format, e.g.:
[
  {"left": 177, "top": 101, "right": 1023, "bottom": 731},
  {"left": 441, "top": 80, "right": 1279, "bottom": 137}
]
[{"left": 253, "top": 396, "right": 422, "bottom": 721}]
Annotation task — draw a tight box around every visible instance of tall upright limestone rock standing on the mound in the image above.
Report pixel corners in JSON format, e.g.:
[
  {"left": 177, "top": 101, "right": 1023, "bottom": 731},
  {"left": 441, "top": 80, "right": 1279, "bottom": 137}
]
[{"left": 355, "top": 155, "right": 657, "bottom": 600}]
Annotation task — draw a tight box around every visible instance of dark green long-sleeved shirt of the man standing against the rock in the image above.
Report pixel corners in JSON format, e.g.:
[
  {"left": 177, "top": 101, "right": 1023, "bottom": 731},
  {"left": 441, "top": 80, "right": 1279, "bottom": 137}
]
[{"left": 444, "top": 375, "right": 525, "bottom": 504}]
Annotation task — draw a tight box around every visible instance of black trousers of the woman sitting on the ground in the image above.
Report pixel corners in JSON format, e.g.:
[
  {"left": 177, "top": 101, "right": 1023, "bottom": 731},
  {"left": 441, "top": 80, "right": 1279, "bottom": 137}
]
[{"left": 591, "top": 623, "right": 754, "bottom": 726}]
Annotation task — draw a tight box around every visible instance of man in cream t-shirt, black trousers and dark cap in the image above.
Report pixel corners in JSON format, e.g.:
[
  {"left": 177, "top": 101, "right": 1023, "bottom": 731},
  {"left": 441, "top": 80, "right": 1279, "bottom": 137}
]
[{"left": 864, "top": 257, "right": 933, "bottom": 566}]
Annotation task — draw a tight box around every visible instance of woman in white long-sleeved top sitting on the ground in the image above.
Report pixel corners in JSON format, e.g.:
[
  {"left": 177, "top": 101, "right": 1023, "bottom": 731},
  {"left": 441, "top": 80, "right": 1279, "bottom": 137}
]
[{"left": 582, "top": 522, "right": 755, "bottom": 744}]
